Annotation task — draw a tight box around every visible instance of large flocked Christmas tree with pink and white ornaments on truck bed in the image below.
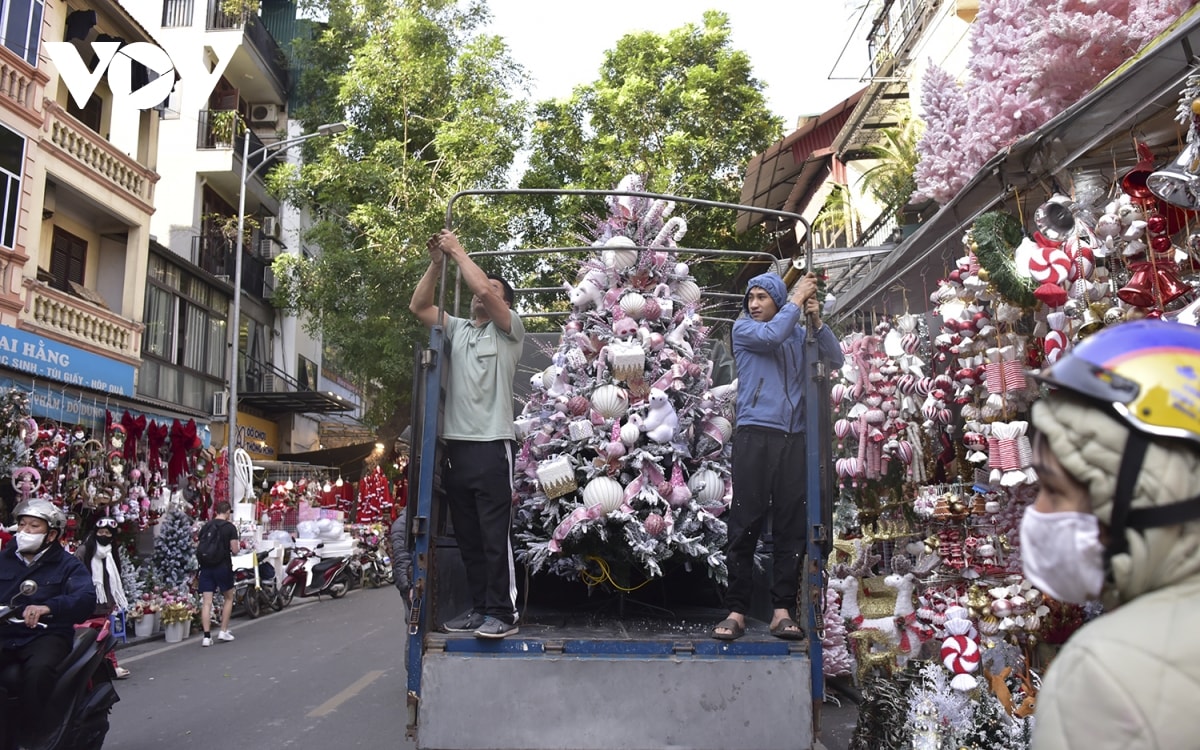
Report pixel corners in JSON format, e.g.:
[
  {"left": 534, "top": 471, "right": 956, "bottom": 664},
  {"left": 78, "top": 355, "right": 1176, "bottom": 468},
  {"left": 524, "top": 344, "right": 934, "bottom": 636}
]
[{"left": 516, "top": 178, "right": 733, "bottom": 588}]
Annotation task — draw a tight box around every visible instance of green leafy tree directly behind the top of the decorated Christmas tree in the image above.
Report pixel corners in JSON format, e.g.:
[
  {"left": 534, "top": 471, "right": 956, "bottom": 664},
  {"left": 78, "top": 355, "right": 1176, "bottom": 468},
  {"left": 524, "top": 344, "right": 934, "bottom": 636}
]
[{"left": 520, "top": 11, "right": 782, "bottom": 295}]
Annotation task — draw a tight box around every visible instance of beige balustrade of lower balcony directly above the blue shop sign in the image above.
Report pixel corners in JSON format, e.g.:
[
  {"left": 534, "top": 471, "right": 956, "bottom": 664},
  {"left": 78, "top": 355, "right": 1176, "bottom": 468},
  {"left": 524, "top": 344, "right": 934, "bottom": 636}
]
[{"left": 24, "top": 278, "right": 144, "bottom": 365}]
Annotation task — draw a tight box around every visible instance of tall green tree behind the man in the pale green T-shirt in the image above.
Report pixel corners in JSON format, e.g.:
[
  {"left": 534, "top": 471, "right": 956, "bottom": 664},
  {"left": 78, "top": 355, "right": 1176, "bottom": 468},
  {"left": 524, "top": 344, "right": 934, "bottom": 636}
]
[{"left": 272, "top": 0, "right": 527, "bottom": 436}]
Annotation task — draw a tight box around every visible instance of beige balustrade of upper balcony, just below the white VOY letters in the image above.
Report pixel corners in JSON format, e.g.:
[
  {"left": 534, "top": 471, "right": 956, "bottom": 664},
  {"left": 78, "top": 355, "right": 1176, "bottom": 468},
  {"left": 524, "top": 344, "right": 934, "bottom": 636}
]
[{"left": 42, "top": 101, "right": 158, "bottom": 211}]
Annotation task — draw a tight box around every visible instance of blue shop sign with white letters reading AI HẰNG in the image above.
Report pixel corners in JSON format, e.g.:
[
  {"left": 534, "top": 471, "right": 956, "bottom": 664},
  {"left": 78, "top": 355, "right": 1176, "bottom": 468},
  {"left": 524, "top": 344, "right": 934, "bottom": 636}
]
[{"left": 0, "top": 325, "right": 136, "bottom": 396}]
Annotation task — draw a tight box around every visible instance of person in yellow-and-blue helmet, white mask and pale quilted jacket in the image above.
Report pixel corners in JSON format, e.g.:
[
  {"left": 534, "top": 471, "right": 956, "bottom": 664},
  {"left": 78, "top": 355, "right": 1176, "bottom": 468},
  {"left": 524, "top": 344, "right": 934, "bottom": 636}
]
[{"left": 1020, "top": 320, "right": 1200, "bottom": 750}]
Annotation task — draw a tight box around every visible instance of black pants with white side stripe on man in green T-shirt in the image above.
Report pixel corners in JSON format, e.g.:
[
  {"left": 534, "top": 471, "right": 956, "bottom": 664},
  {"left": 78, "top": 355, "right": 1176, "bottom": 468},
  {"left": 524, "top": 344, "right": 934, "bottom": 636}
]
[{"left": 442, "top": 440, "right": 517, "bottom": 623}]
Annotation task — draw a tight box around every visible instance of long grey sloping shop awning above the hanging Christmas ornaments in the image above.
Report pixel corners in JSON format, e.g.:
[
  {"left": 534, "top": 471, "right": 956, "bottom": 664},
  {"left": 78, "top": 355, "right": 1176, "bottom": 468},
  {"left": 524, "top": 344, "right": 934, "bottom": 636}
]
[{"left": 830, "top": 6, "right": 1200, "bottom": 320}]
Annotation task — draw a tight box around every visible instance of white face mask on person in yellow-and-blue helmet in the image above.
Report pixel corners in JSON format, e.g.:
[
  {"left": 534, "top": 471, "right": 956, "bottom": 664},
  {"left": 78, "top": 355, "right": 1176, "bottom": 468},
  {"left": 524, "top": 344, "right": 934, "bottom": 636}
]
[{"left": 1021, "top": 506, "right": 1104, "bottom": 604}]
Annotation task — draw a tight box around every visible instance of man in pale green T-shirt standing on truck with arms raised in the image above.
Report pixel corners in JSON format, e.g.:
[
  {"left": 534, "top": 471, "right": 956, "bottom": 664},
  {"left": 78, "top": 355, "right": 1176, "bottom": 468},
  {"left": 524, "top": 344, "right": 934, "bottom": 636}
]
[{"left": 408, "top": 229, "right": 524, "bottom": 638}]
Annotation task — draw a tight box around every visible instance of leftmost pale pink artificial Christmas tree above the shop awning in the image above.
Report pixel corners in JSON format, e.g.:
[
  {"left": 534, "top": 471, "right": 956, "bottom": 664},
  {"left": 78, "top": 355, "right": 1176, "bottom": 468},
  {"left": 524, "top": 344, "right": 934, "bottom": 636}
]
[{"left": 913, "top": 65, "right": 971, "bottom": 204}]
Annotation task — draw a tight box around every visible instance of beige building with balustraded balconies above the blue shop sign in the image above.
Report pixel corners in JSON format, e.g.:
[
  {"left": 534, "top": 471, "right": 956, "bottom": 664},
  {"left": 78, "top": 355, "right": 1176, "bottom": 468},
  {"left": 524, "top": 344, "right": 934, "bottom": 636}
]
[{"left": 0, "top": 0, "right": 209, "bottom": 439}]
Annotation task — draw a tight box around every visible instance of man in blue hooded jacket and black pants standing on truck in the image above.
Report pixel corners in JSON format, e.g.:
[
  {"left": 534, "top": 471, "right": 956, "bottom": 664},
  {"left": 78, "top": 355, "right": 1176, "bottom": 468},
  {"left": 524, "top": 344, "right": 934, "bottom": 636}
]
[{"left": 713, "top": 268, "right": 844, "bottom": 641}]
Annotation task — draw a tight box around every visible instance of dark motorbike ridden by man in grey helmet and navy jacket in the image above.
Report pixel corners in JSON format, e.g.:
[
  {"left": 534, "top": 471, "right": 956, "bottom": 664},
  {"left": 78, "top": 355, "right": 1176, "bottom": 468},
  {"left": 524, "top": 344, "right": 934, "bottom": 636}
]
[{"left": 0, "top": 581, "right": 120, "bottom": 750}]
